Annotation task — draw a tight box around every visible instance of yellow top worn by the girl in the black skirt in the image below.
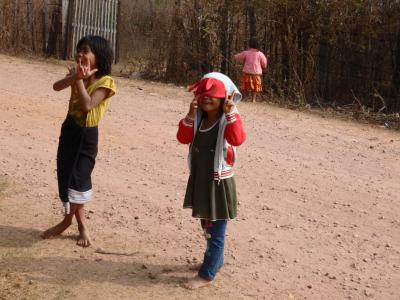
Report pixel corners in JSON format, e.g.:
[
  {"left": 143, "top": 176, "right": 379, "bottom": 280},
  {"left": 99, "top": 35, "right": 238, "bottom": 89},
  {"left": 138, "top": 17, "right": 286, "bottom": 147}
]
[{"left": 68, "top": 75, "right": 116, "bottom": 127}]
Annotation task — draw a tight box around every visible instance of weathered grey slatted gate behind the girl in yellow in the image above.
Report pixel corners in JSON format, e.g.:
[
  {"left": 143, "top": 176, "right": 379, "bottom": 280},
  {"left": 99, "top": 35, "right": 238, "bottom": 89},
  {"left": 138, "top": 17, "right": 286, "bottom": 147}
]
[{"left": 63, "top": 0, "right": 119, "bottom": 59}]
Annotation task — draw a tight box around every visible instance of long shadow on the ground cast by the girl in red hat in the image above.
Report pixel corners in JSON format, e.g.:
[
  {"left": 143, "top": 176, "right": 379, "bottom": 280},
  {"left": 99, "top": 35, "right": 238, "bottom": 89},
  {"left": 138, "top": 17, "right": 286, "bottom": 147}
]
[{"left": 0, "top": 255, "right": 194, "bottom": 287}]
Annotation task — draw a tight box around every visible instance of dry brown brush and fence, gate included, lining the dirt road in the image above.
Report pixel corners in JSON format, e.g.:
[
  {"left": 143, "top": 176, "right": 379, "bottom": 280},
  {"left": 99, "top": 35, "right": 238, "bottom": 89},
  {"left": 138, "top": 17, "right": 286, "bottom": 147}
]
[{"left": 0, "top": 0, "right": 400, "bottom": 116}]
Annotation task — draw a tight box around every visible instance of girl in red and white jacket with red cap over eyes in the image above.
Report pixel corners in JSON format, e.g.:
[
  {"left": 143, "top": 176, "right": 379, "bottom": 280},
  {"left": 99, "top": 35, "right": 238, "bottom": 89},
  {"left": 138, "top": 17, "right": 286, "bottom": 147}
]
[{"left": 177, "top": 72, "right": 246, "bottom": 289}]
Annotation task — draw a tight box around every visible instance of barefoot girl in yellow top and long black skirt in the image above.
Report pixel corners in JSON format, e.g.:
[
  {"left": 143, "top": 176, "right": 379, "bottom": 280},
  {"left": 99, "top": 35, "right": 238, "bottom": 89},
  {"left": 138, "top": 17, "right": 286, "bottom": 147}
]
[{"left": 42, "top": 36, "right": 115, "bottom": 247}]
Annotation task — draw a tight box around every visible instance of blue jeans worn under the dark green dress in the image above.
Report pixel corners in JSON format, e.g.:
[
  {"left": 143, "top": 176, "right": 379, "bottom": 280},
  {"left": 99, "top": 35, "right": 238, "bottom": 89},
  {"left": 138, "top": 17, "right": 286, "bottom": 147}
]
[{"left": 199, "top": 220, "right": 227, "bottom": 280}]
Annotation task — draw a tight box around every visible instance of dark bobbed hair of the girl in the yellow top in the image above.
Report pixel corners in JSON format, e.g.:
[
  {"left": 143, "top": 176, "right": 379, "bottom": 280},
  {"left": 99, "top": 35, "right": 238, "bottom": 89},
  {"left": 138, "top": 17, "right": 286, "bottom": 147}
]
[{"left": 76, "top": 35, "right": 113, "bottom": 78}]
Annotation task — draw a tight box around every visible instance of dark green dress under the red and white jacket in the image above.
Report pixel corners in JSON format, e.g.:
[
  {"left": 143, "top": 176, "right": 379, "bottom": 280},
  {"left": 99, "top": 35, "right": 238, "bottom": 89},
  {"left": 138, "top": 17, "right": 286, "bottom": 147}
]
[{"left": 183, "top": 122, "right": 237, "bottom": 221}]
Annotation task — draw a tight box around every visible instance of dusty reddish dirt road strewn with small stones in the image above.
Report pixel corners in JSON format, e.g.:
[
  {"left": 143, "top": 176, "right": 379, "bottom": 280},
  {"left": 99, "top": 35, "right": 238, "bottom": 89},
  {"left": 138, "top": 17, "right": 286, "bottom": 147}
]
[{"left": 0, "top": 55, "right": 400, "bottom": 299}]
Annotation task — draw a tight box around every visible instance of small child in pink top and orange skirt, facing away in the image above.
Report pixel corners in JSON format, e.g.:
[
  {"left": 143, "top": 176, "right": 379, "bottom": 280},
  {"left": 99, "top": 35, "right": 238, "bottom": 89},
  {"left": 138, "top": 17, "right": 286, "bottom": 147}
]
[{"left": 234, "top": 37, "right": 267, "bottom": 102}]
